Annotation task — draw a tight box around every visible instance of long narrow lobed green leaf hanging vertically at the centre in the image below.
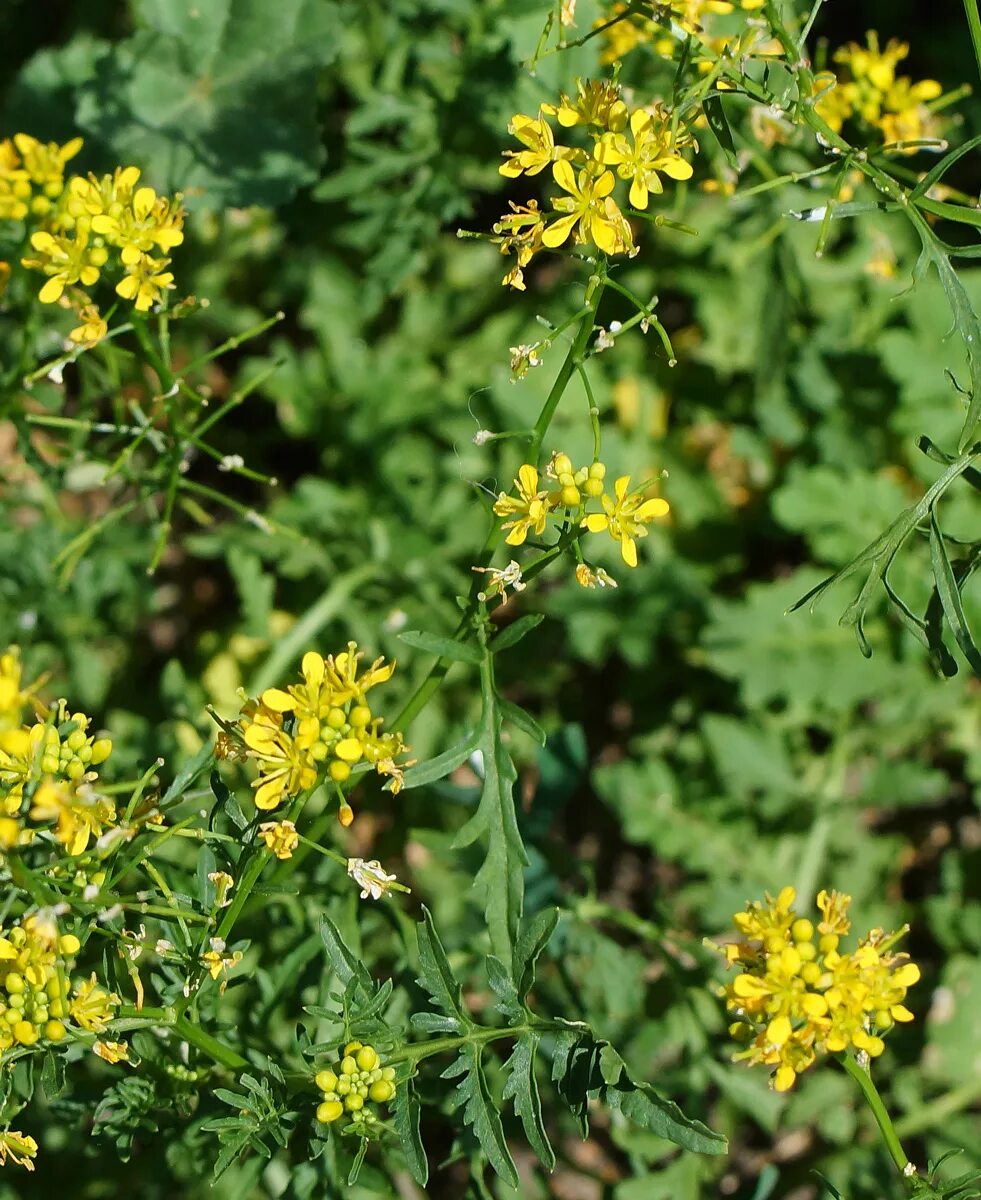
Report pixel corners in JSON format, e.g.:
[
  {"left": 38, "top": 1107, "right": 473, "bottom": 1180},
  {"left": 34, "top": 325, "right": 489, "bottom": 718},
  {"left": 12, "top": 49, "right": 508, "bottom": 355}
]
[{"left": 453, "top": 653, "right": 528, "bottom": 972}]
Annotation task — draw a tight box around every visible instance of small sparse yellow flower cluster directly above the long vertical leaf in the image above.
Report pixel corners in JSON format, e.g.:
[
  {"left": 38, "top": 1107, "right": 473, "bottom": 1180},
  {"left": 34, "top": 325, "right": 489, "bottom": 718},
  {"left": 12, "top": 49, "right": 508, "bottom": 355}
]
[{"left": 494, "top": 454, "right": 670, "bottom": 568}]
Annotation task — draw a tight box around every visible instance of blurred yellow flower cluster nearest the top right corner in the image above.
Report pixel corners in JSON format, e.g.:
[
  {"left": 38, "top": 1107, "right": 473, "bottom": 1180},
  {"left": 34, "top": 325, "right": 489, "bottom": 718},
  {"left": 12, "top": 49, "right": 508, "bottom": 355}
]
[{"left": 814, "top": 31, "right": 943, "bottom": 152}]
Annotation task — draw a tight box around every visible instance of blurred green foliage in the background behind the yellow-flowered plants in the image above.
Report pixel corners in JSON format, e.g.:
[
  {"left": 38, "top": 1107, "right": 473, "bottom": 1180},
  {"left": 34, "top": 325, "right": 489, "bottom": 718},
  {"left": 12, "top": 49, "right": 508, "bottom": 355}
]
[{"left": 0, "top": 0, "right": 981, "bottom": 1200}]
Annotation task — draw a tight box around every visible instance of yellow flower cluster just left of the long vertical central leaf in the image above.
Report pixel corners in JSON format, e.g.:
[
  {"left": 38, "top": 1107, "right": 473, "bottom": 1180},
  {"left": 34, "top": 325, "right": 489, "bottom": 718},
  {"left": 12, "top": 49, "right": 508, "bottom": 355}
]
[{"left": 239, "top": 642, "right": 405, "bottom": 816}]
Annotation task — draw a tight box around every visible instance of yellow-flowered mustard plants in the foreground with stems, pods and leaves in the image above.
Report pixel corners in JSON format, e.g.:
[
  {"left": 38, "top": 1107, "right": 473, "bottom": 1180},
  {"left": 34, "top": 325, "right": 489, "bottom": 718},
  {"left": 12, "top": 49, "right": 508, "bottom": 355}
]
[{"left": 0, "top": 0, "right": 981, "bottom": 1198}]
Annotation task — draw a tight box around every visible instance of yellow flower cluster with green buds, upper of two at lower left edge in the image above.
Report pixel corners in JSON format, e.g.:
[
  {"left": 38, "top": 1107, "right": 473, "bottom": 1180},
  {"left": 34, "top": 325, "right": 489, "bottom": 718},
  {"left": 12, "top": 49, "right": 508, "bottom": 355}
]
[{"left": 0, "top": 649, "right": 116, "bottom": 857}]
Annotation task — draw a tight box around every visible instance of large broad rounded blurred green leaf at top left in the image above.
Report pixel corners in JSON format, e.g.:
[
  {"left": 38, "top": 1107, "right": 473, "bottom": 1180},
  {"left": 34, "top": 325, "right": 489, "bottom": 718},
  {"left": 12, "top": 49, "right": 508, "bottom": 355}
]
[{"left": 76, "top": 0, "right": 339, "bottom": 208}]
